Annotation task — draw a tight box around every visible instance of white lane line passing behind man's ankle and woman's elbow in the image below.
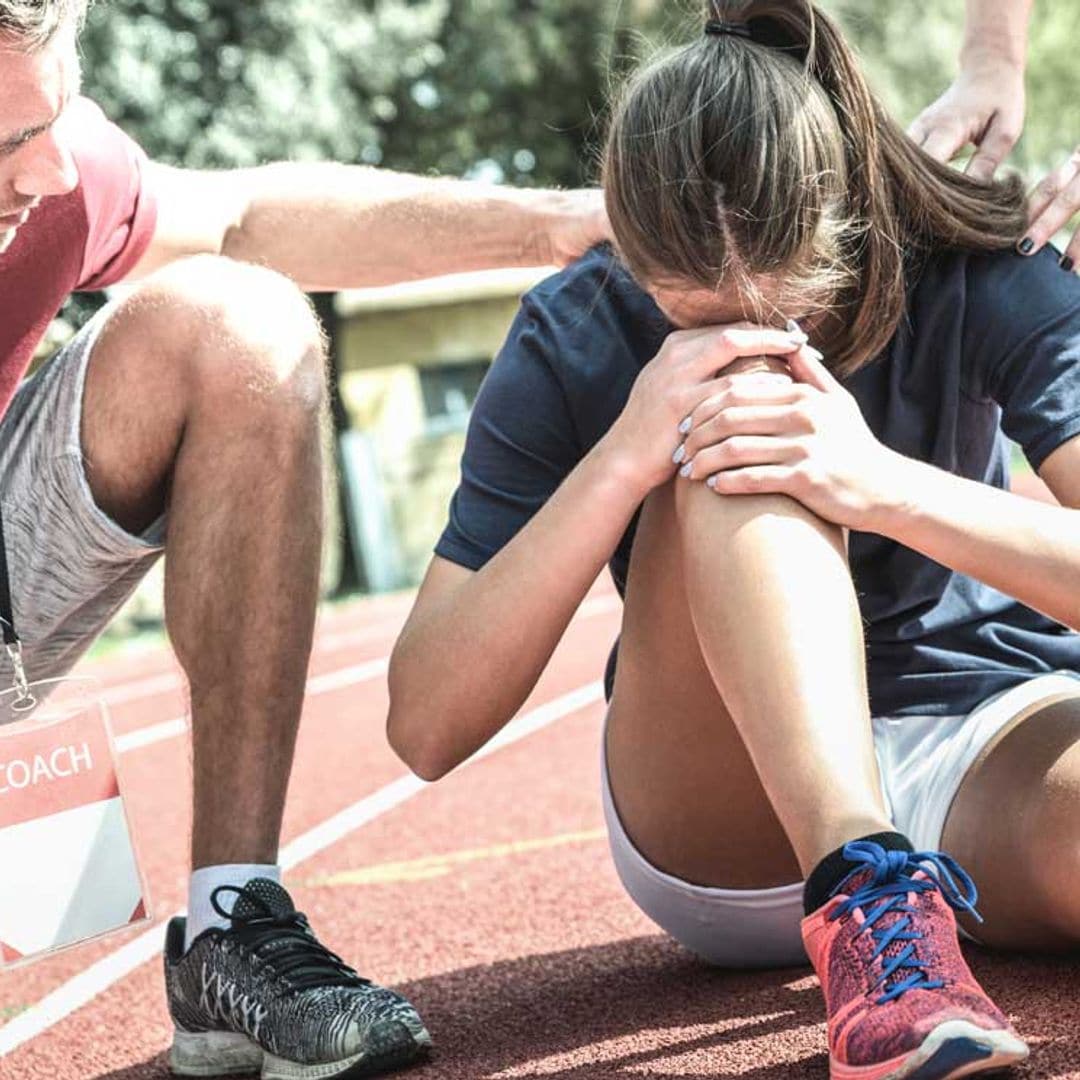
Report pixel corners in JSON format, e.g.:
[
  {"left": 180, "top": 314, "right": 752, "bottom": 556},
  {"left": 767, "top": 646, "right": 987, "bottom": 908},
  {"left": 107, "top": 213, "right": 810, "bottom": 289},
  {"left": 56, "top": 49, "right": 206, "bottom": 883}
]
[{"left": 0, "top": 683, "right": 604, "bottom": 1057}]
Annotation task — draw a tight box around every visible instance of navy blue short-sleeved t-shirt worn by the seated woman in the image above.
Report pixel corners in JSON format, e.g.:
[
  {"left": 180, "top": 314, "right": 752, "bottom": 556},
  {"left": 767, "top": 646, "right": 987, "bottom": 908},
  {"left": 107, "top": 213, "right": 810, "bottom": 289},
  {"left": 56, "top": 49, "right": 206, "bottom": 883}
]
[{"left": 435, "top": 247, "right": 1080, "bottom": 716}]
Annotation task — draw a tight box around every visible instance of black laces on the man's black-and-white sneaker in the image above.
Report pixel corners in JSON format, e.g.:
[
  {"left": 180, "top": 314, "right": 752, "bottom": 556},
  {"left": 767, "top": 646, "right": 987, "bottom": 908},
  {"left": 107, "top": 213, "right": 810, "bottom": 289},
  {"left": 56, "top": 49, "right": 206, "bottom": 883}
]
[{"left": 210, "top": 885, "right": 372, "bottom": 993}]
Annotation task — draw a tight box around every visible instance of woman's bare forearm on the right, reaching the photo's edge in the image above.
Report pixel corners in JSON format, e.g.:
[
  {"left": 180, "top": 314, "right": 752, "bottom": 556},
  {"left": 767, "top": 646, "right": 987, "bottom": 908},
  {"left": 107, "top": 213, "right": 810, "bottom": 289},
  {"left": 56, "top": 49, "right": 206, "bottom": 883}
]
[{"left": 870, "top": 455, "right": 1080, "bottom": 630}]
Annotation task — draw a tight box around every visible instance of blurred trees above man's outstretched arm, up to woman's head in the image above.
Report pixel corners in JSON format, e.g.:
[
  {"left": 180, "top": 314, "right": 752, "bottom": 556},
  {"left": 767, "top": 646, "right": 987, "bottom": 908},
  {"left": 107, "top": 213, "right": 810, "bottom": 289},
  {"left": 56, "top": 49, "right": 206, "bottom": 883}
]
[{"left": 82, "top": 0, "right": 639, "bottom": 185}]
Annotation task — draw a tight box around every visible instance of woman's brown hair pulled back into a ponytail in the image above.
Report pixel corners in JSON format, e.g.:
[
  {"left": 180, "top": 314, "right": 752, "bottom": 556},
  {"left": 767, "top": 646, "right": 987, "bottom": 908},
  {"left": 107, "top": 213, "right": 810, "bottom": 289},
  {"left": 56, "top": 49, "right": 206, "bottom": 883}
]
[{"left": 604, "top": 0, "right": 1025, "bottom": 376}]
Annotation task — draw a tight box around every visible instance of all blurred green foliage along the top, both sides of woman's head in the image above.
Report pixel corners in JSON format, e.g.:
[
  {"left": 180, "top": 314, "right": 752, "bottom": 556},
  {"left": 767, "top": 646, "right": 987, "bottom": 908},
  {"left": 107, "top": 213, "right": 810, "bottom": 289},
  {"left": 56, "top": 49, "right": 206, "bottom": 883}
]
[{"left": 83, "top": 0, "right": 1080, "bottom": 185}]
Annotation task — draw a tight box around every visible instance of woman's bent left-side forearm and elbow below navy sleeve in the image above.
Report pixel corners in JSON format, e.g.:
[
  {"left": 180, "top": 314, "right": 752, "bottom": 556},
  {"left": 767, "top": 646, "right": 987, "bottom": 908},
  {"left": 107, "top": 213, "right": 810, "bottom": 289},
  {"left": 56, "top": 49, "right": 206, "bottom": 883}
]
[{"left": 389, "top": 442, "right": 647, "bottom": 780}]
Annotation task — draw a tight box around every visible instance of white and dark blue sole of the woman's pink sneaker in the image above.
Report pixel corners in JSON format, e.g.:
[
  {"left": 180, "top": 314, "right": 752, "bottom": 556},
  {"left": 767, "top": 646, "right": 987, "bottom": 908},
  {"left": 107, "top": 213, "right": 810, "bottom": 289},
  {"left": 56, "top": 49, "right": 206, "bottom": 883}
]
[{"left": 828, "top": 1020, "right": 1029, "bottom": 1080}]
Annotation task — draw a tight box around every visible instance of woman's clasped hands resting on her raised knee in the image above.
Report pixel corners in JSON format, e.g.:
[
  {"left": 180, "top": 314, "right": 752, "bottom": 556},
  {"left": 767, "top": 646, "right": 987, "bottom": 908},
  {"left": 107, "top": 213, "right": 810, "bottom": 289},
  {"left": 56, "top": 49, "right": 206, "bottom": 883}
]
[{"left": 611, "top": 323, "right": 906, "bottom": 530}]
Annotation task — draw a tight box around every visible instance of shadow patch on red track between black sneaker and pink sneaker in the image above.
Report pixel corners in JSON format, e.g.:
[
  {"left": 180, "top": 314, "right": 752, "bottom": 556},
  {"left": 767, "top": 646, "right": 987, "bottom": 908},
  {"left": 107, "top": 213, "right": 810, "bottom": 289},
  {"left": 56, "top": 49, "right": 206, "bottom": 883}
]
[{"left": 401, "top": 935, "right": 825, "bottom": 1080}]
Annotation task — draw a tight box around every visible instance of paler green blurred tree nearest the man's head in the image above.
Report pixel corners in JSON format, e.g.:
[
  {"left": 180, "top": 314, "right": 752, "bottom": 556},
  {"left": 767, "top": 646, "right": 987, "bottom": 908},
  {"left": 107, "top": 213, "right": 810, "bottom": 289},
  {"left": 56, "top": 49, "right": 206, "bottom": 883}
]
[{"left": 82, "top": 0, "right": 446, "bottom": 167}]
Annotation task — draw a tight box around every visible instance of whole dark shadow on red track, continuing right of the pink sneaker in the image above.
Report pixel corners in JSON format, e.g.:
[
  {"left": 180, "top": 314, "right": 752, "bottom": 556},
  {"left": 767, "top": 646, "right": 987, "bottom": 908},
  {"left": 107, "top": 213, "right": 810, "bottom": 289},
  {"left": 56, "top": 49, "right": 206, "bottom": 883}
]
[{"left": 90, "top": 935, "right": 1080, "bottom": 1080}]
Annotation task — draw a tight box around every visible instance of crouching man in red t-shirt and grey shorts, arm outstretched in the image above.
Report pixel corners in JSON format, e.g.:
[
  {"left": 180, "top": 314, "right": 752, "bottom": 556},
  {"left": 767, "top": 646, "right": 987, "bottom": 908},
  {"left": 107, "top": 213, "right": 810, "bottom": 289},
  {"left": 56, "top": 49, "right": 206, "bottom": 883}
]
[{"left": 0, "top": 0, "right": 605, "bottom": 1078}]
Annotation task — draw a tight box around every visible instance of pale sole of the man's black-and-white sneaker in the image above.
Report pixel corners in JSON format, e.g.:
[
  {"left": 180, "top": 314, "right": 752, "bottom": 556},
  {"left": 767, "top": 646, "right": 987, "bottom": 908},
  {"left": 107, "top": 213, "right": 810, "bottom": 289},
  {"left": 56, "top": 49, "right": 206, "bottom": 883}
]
[{"left": 168, "top": 1025, "right": 431, "bottom": 1080}]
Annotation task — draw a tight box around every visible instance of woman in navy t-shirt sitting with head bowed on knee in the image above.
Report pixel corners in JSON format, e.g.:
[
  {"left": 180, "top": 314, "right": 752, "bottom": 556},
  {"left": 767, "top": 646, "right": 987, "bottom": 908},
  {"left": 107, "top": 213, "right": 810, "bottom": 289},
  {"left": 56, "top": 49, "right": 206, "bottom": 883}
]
[{"left": 389, "top": 0, "right": 1080, "bottom": 1080}]
